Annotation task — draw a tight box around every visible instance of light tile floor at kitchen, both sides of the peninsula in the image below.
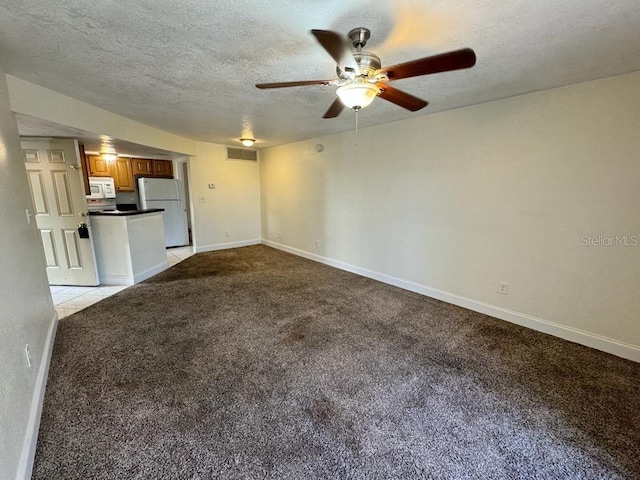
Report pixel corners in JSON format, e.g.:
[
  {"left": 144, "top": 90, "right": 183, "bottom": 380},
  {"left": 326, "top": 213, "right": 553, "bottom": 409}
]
[{"left": 50, "top": 247, "right": 193, "bottom": 318}]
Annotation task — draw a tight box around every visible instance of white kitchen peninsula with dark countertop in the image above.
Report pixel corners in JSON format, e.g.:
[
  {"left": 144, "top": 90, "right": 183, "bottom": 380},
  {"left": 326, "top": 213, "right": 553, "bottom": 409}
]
[{"left": 89, "top": 208, "right": 169, "bottom": 285}]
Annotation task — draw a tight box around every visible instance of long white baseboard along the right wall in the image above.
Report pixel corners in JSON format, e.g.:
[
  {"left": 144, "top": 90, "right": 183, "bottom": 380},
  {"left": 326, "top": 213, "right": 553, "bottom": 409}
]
[{"left": 262, "top": 239, "right": 640, "bottom": 362}]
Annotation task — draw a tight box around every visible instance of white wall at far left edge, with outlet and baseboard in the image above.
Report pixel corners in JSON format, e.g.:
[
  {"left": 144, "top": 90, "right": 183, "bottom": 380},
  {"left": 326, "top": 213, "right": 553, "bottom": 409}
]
[{"left": 0, "top": 71, "right": 56, "bottom": 478}]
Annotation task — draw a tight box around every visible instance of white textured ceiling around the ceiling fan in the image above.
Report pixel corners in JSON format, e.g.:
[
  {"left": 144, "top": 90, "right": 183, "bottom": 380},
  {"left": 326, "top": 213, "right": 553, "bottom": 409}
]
[{"left": 0, "top": 0, "right": 640, "bottom": 152}]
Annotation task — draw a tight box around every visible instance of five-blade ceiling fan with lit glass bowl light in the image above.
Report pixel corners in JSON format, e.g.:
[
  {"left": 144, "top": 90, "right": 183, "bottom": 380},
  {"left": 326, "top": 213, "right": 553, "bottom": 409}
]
[{"left": 256, "top": 27, "right": 476, "bottom": 118}]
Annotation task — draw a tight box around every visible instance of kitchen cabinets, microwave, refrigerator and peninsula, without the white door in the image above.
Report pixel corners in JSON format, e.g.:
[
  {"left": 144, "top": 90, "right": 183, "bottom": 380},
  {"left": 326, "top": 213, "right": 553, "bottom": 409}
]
[{"left": 80, "top": 151, "right": 191, "bottom": 285}]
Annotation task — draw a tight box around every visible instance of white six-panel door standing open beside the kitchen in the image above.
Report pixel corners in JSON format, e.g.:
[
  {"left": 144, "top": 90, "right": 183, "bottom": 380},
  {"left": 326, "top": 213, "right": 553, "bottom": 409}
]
[{"left": 22, "top": 139, "right": 99, "bottom": 286}]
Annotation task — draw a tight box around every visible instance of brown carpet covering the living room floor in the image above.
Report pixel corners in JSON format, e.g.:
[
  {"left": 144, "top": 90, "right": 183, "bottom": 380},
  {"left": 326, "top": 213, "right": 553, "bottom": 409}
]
[{"left": 34, "top": 246, "right": 640, "bottom": 480}]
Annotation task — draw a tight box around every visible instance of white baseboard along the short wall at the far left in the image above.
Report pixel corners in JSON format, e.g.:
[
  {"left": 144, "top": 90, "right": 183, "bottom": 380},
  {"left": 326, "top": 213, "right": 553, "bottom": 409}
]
[{"left": 16, "top": 313, "right": 58, "bottom": 480}]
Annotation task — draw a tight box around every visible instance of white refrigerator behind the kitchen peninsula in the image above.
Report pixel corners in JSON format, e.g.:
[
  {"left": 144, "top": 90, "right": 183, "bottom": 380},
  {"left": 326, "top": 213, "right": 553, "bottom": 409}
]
[{"left": 138, "top": 177, "right": 189, "bottom": 247}]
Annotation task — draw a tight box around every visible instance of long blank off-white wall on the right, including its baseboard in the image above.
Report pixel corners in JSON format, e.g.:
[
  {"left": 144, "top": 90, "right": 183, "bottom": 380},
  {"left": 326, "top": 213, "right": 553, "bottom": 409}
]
[{"left": 261, "top": 72, "right": 640, "bottom": 361}]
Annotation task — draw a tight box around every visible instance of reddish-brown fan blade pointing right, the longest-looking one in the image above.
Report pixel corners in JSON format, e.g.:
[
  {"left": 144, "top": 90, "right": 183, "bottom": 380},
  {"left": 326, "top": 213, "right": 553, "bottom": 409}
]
[{"left": 376, "top": 48, "right": 476, "bottom": 80}]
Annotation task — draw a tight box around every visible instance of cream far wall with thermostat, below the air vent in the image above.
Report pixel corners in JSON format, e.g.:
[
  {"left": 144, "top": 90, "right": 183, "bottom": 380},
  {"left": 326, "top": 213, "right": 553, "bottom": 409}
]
[{"left": 189, "top": 142, "right": 261, "bottom": 252}]
